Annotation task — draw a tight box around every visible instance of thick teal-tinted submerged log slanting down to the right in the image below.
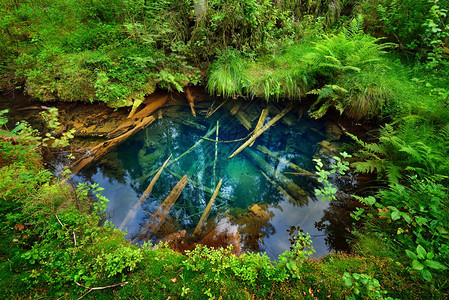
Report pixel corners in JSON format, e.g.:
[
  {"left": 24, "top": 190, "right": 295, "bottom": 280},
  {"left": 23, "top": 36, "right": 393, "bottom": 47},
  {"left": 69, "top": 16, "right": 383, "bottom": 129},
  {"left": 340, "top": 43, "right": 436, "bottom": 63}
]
[{"left": 245, "top": 148, "right": 308, "bottom": 204}]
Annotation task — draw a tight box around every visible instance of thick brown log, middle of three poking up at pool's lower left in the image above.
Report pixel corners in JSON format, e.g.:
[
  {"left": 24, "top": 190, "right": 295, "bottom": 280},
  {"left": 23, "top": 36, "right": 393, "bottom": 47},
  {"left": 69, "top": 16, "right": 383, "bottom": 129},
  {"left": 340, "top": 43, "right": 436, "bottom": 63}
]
[{"left": 139, "top": 175, "right": 187, "bottom": 236}]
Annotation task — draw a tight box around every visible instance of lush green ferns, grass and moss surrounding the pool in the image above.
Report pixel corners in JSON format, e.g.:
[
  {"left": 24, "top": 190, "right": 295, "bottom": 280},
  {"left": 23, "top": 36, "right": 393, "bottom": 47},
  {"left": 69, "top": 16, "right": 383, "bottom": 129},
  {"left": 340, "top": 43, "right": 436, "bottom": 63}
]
[{"left": 0, "top": 0, "right": 449, "bottom": 299}]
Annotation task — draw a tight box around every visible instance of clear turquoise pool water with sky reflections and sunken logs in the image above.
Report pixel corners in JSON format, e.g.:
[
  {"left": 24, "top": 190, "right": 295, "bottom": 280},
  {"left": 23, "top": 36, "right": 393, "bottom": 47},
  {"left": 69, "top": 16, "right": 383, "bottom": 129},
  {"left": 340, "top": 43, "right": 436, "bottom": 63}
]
[{"left": 79, "top": 99, "right": 353, "bottom": 258}]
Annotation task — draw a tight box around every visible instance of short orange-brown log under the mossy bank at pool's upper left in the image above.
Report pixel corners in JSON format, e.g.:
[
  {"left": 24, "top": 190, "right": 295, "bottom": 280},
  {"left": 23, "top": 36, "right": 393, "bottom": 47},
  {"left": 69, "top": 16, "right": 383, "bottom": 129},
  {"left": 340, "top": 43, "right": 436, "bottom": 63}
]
[{"left": 108, "top": 95, "right": 168, "bottom": 138}]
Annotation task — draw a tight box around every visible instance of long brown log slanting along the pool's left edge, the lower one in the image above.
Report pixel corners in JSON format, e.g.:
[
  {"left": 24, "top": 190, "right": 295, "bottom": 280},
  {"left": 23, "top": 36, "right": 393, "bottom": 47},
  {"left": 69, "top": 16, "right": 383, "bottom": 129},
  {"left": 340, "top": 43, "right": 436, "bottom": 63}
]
[{"left": 69, "top": 116, "right": 156, "bottom": 174}]
